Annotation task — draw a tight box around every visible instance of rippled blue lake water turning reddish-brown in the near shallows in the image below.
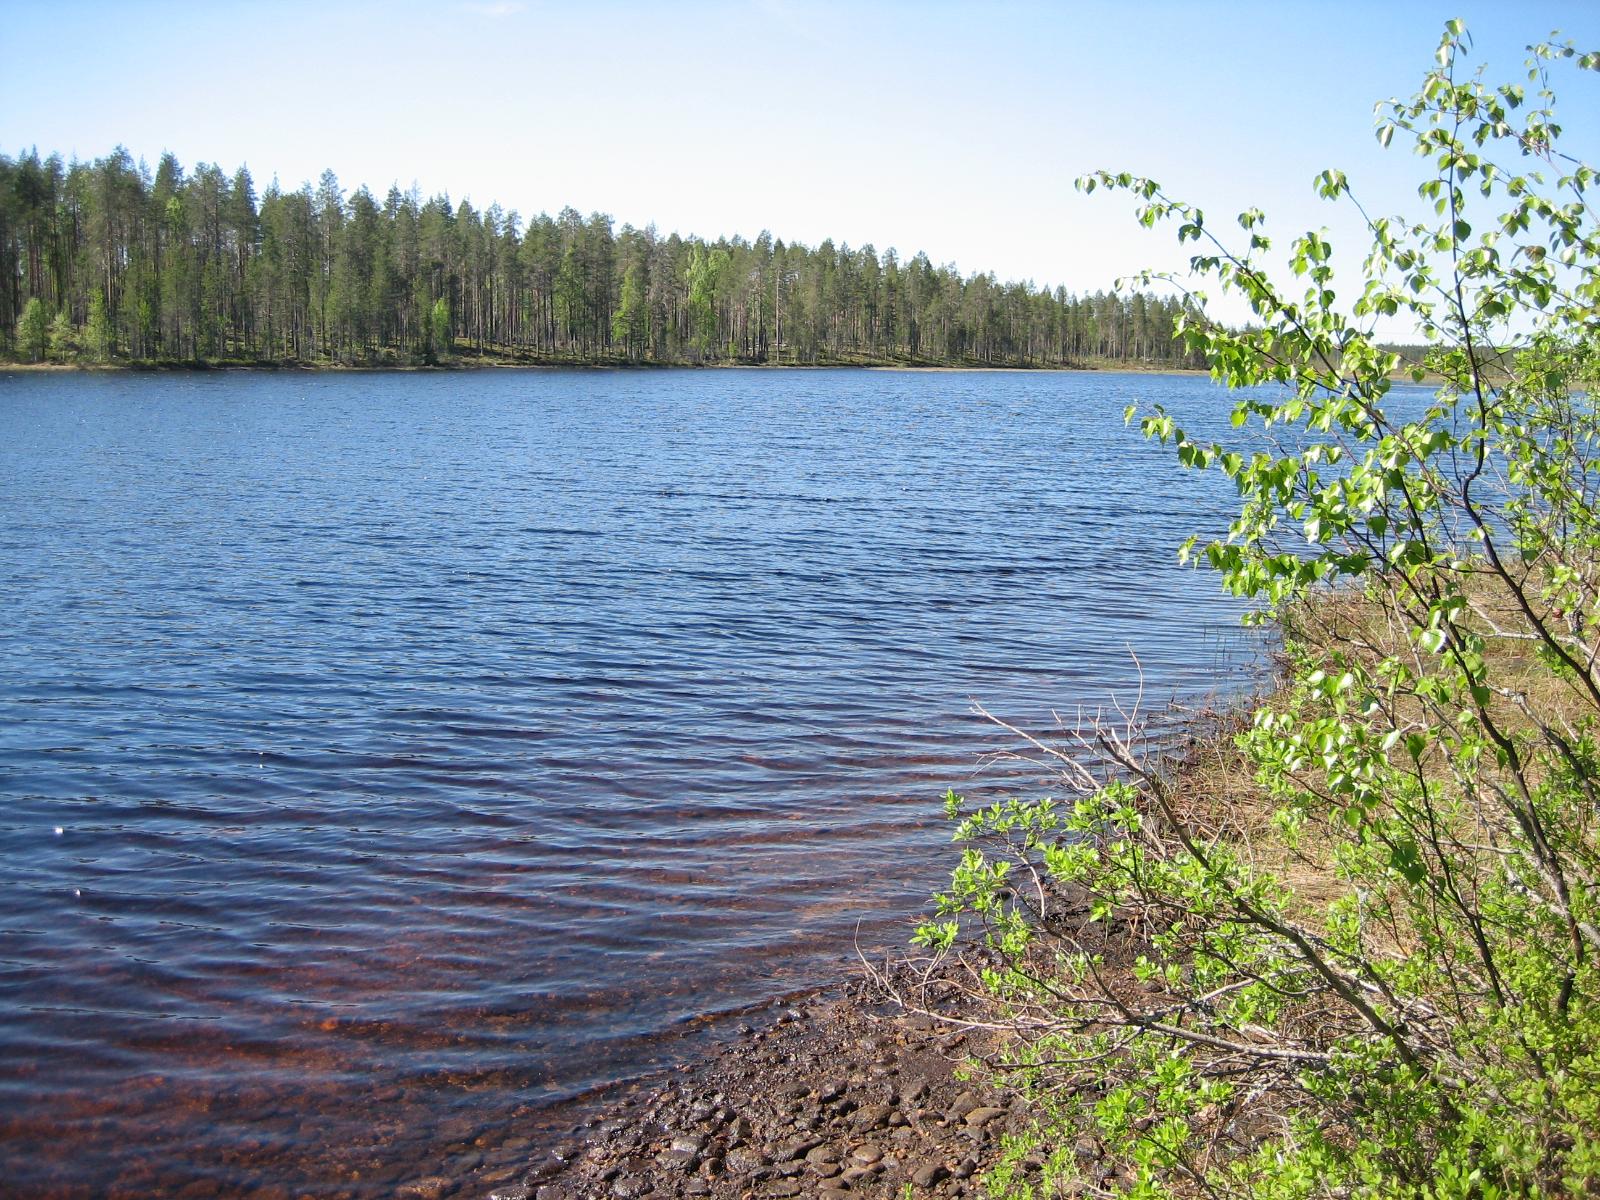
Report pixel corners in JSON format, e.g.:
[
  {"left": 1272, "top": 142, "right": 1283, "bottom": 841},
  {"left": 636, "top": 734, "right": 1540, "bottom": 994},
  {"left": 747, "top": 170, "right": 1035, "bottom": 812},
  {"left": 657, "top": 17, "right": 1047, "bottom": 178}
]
[{"left": 0, "top": 371, "right": 1260, "bottom": 1197}]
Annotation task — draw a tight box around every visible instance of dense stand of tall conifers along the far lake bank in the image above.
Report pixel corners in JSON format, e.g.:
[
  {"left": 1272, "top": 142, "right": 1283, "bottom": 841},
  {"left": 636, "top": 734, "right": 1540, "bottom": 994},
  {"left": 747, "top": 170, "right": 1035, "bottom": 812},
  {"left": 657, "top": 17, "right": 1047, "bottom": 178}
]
[{"left": 0, "top": 147, "right": 1198, "bottom": 366}]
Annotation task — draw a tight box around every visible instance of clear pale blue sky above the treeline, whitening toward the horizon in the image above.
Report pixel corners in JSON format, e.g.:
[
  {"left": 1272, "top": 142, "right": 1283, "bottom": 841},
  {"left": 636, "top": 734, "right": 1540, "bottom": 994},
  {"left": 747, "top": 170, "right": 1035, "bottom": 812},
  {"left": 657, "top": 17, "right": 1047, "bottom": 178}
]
[{"left": 0, "top": 0, "right": 1600, "bottom": 336}]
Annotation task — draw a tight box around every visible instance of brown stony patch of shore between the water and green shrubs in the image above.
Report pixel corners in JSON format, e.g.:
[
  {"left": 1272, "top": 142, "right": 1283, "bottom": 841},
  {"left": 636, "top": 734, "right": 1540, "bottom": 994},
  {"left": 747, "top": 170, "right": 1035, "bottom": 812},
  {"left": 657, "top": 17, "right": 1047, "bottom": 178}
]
[{"left": 464, "top": 981, "right": 1026, "bottom": 1200}]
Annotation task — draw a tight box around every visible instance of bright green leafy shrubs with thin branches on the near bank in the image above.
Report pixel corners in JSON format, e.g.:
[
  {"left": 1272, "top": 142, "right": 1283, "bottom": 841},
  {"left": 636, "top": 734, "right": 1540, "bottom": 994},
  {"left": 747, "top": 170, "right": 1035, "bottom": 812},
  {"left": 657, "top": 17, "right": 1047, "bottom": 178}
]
[{"left": 917, "top": 22, "right": 1600, "bottom": 1200}]
